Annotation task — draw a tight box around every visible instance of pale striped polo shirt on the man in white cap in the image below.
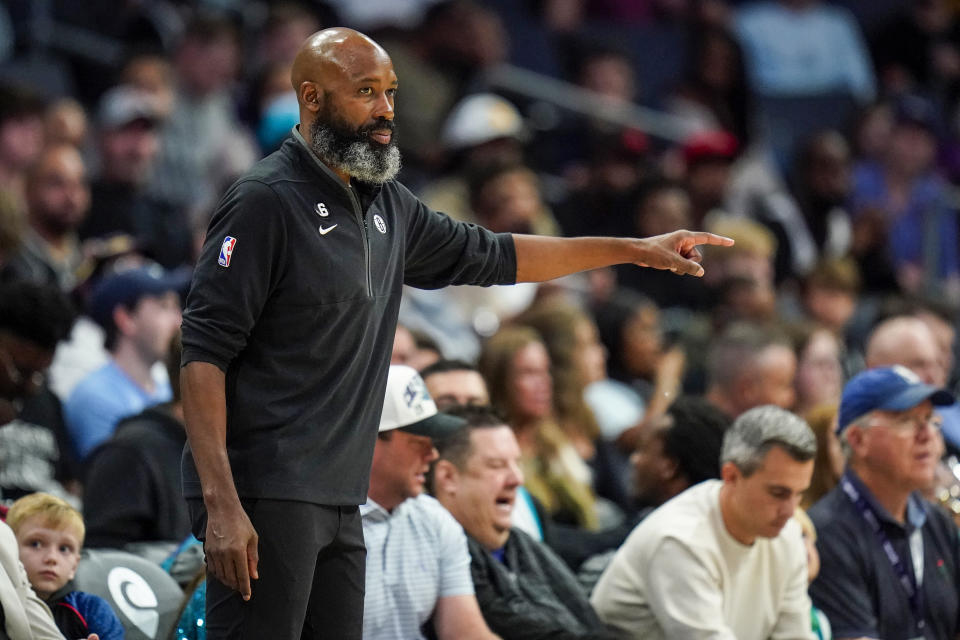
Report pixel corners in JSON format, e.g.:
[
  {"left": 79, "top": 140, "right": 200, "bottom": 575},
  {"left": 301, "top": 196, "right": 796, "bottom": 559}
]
[{"left": 360, "top": 495, "right": 473, "bottom": 640}]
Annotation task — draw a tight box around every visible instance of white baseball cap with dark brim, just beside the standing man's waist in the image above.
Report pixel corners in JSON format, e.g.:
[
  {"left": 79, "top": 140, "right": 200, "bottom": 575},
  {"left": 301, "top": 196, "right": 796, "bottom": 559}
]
[{"left": 380, "top": 364, "right": 467, "bottom": 439}]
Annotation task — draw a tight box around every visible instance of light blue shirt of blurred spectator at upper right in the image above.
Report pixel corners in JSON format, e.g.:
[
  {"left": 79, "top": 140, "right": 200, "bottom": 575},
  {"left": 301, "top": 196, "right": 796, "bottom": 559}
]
[{"left": 734, "top": 2, "right": 876, "bottom": 102}]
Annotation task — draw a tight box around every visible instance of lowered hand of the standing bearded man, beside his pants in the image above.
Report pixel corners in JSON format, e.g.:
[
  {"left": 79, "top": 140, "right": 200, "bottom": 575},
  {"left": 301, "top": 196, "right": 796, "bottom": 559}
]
[{"left": 204, "top": 503, "right": 260, "bottom": 600}]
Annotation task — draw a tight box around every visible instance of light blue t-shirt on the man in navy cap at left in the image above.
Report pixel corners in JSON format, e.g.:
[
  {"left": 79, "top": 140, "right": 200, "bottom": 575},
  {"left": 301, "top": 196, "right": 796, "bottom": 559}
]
[{"left": 63, "top": 360, "right": 173, "bottom": 459}]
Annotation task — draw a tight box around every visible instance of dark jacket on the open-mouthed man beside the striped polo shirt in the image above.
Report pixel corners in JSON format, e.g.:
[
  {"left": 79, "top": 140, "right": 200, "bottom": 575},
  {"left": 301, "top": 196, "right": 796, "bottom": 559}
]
[{"left": 467, "top": 529, "right": 622, "bottom": 640}]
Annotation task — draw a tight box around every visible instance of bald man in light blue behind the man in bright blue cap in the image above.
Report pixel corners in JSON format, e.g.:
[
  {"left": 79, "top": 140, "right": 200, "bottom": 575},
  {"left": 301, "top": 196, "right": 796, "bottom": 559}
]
[{"left": 864, "top": 315, "right": 960, "bottom": 452}]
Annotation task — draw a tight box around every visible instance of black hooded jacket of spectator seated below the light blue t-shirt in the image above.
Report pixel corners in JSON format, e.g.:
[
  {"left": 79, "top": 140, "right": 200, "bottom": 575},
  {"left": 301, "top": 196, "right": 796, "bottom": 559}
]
[{"left": 83, "top": 406, "right": 190, "bottom": 549}]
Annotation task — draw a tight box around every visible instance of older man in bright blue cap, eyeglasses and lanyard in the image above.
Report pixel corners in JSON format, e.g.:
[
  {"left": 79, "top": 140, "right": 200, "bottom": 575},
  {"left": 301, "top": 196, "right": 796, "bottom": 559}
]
[{"left": 810, "top": 365, "right": 960, "bottom": 640}]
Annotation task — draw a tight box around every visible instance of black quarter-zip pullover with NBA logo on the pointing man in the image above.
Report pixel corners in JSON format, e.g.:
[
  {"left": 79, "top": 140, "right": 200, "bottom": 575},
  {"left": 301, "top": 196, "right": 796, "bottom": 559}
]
[{"left": 176, "top": 139, "right": 516, "bottom": 505}]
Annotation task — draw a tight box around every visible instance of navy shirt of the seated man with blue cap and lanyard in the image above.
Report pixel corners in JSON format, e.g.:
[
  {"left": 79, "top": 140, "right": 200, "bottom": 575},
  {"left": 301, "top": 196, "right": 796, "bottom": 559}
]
[{"left": 810, "top": 470, "right": 960, "bottom": 640}]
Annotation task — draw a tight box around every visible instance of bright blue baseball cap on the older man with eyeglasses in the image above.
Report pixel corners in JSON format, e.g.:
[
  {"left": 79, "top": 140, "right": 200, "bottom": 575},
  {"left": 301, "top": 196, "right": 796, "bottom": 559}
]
[{"left": 837, "top": 365, "right": 955, "bottom": 435}]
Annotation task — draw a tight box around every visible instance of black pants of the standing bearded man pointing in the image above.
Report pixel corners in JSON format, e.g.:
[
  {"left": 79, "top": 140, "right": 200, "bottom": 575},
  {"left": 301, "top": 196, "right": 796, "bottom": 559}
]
[{"left": 188, "top": 500, "right": 367, "bottom": 640}]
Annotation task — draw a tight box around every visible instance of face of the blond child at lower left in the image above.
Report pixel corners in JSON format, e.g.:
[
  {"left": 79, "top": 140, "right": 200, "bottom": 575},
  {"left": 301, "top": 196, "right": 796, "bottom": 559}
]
[{"left": 17, "top": 516, "right": 80, "bottom": 599}]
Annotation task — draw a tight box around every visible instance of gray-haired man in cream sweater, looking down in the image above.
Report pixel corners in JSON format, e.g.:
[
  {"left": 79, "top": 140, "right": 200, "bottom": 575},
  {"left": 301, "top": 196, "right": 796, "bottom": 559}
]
[{"left": 591, "top": 405, "right": 816, "bottom": 640}]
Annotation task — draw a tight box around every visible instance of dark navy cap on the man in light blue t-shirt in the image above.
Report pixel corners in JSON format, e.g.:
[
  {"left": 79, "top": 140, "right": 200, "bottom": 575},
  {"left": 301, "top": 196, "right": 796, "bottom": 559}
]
[{"left": 87, "top": 264, "right": 191, "bottom": 327}]
